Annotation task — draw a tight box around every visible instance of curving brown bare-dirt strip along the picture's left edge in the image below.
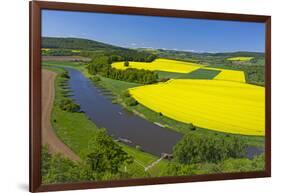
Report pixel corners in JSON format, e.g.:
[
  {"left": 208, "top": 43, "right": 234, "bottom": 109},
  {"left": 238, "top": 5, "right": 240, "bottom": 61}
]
[{"left": 42, "top": 70, "right": 81, "bottom": 161}]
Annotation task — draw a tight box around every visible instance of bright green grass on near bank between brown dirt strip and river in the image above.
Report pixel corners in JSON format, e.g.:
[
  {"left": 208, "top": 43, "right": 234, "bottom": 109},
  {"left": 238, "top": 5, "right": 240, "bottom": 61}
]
[{"left": 41, "top": 66, "right": 167, "bottom": 177}]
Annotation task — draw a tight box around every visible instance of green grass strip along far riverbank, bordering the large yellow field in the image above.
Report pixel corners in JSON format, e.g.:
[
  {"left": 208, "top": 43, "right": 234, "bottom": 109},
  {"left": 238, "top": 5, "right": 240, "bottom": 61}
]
[{"left": 44, "top": 61, "right": 264, "bottom": 147}]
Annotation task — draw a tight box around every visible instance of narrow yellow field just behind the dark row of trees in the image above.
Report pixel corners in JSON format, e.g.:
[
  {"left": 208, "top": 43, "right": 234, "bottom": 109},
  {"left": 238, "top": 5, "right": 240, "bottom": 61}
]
[{"left": 112, "top": 58, "right": 202, "bottom": 73}]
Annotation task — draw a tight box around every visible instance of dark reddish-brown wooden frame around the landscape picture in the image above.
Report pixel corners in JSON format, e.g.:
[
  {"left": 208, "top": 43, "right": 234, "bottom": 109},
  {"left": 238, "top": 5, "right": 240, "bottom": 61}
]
[{"left": 29, "top": 1, "right": 271, "bottom": 192}]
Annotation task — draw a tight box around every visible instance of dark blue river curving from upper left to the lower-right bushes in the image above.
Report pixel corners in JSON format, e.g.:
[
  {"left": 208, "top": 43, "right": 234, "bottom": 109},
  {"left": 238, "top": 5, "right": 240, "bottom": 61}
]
[{"left": 67, "top": 68, "right": 182, "bottom": 156}]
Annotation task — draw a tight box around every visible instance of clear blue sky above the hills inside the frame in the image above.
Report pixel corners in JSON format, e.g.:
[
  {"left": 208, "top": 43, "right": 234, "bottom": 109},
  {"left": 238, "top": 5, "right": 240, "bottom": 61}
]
[{"left": 42, "top": 10, "right": 265, "bottom": 52}]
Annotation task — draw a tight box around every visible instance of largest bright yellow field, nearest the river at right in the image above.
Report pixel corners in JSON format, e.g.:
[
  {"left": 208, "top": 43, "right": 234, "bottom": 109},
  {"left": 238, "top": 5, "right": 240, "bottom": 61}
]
[{"left": 129, "top": 79, "right": 265, "bottom": 136}]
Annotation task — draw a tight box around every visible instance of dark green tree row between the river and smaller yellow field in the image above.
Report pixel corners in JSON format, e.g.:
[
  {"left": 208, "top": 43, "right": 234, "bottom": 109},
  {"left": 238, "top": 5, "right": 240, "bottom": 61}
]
[{"left": 88, "top": 55, "right": 158, "bottom": 84}]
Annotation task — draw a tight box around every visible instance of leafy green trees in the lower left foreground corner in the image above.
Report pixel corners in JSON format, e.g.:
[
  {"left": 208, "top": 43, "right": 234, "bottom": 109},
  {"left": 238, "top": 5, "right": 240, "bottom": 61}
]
[{"left": 41, "top": 129, "right": 133, "bottom": 184}]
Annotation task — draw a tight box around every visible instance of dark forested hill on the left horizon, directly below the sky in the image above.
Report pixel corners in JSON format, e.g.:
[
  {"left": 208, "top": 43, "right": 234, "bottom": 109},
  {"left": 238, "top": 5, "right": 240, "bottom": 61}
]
[{"left": 42, "top": 37, "right": 128, "bottom": 50}]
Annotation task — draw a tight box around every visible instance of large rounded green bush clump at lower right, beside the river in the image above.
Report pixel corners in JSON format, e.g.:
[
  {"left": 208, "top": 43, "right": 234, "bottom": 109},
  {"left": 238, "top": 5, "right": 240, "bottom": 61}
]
[{"left": 173, "top": 134, "right": 246, "bottom": 164}]
